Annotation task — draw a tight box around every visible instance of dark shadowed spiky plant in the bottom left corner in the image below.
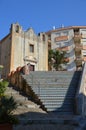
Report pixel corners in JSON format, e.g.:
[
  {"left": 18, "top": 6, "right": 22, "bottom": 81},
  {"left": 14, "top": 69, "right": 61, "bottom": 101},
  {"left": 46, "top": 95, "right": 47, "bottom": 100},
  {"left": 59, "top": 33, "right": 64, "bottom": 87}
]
[{"left": 0, "top": 96, "right": 18, "bottom": 124}]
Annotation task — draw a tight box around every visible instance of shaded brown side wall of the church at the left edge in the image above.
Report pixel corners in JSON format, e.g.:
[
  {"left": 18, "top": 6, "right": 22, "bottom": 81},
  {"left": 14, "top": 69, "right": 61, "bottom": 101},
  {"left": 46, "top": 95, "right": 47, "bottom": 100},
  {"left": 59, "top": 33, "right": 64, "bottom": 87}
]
[{"left": 0, "top": 34, "right": 11, "bottom": 77}]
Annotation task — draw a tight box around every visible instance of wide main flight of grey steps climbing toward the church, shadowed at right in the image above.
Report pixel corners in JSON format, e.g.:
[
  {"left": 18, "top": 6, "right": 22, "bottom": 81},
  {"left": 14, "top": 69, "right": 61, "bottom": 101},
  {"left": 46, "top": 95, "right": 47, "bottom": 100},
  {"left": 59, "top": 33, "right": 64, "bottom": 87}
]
[{"left": 22, "top": 71, "right": 81, "bottom": 115}]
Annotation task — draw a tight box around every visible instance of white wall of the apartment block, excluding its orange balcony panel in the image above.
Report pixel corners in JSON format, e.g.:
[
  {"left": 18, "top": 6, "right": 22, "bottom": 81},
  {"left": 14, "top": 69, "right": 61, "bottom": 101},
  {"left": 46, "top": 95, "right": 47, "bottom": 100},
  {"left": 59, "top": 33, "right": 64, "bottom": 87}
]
[{"left": 51, "top": 29, "right": 76, "bottom": 70}]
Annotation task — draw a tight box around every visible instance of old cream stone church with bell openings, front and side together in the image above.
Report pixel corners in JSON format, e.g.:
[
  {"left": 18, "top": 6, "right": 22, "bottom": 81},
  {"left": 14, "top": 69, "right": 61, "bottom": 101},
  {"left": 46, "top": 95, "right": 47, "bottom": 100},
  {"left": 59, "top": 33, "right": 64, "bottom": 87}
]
[{"left": 0, "top": 23, "right": 48, "bottom": 76}]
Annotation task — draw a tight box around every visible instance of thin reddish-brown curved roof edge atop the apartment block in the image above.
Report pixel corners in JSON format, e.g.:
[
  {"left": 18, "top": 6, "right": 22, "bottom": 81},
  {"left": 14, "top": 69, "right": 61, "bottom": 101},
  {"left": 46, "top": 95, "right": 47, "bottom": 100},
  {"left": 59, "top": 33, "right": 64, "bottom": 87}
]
[{"left": 45, "top": 26, "right": 86, "bottom": 34}]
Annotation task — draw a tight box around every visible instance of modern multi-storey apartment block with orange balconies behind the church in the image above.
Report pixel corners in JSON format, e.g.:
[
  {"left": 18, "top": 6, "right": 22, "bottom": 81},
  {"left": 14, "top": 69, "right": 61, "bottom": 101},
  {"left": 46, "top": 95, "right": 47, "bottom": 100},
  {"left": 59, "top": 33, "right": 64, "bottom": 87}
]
[{"left": 46, "top": 26, "right": 86, "bottom": 71}]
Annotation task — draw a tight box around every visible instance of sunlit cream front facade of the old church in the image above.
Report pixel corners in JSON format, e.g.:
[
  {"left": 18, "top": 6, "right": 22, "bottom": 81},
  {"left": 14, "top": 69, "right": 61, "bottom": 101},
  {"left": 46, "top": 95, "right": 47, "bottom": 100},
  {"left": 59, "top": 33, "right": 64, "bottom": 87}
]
[{"left": 11, "top": 24, "right": 48, "bottom": 71}]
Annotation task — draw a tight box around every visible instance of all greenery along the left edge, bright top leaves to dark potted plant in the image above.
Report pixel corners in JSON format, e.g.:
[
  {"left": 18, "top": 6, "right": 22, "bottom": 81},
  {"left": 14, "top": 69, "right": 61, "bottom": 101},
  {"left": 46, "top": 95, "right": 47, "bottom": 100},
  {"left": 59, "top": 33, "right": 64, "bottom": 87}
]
[{"left": 0, "top": 80, "right": 18, "bottom": 130}]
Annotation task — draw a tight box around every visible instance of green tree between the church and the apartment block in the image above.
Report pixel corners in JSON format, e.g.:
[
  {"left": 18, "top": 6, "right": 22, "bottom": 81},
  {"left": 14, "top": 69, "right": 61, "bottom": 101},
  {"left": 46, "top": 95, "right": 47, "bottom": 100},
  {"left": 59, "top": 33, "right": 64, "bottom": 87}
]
[{"left": 48, "top": 50, "right": 66, "bottom": 70}]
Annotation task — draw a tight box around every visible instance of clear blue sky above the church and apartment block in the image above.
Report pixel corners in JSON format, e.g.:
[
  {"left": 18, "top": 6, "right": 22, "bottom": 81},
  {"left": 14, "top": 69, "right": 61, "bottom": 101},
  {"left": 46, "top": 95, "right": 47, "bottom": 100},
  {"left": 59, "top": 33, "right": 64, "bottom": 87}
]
[{"left": 0, "top": 0, "right": 86, "bottom": 39}]
